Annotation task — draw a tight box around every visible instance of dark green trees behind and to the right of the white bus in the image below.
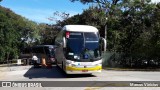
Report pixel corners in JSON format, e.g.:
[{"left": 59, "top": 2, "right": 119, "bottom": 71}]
[{"left": 66, "top": 0, "right": 160, "bottom": 66}]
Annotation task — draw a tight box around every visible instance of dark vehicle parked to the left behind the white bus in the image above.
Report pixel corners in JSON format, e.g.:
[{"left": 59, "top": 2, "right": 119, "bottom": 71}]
[{"left": 20, "top": 45, "right": 55, "bottom": 66}]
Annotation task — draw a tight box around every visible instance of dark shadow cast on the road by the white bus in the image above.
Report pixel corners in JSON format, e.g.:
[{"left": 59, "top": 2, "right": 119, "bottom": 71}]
[{"left": 24, "top": 66, "right": 95, "bottom": 79}]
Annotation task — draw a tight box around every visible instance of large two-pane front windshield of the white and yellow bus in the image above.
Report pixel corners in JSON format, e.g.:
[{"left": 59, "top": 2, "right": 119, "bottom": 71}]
[{"left": 66, "top": 32, "right": 100, "bottom": 61}]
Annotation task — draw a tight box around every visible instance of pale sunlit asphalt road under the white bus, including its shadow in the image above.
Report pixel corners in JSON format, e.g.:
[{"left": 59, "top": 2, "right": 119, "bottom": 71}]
[{"left": 0, "top": 66, "right": 160, "bottom": 90}]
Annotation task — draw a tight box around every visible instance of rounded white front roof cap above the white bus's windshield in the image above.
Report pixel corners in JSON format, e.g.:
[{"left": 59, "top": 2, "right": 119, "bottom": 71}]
[{"left": 63, "top": 25, "right": 98, "bottom": 32}]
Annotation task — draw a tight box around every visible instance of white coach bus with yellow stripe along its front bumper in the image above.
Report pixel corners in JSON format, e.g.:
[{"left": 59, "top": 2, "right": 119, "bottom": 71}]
[{"left": 55, "top": 25, "right": 106, "bottom": 74}]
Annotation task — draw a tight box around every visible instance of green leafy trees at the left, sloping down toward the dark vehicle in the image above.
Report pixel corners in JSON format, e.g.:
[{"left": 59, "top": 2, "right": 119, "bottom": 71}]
[{"left": 0, "top": 6, "right": 47, "bottom": 61}]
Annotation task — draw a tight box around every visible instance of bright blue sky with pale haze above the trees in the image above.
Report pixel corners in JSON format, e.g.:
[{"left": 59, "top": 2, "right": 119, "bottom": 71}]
[{"left": 0, "top": 0, "right": 160, "bottom": 24}]
